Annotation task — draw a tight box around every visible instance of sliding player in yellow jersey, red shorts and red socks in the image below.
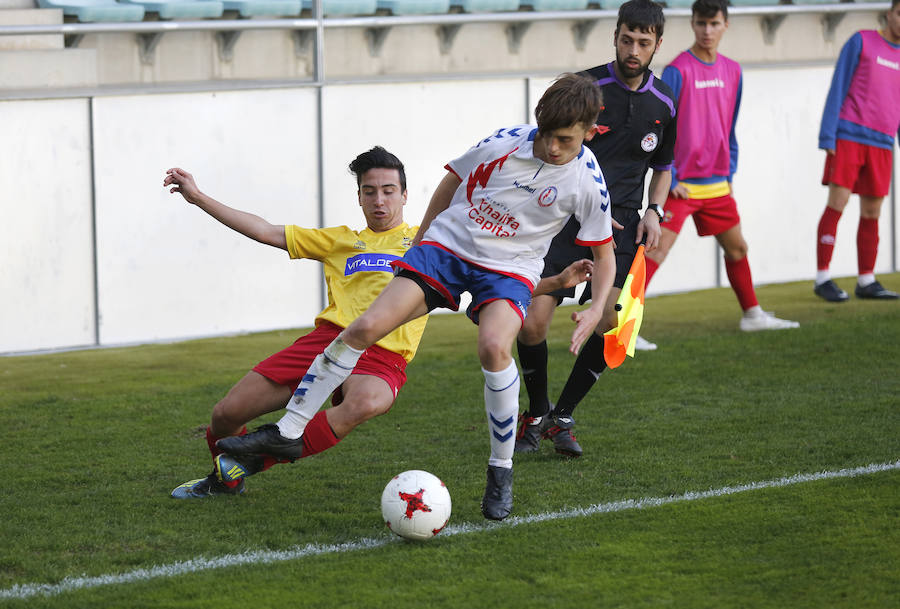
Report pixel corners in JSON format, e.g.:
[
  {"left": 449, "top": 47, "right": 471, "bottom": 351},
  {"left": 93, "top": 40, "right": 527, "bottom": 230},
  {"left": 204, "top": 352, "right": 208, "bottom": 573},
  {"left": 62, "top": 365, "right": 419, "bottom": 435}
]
[{"left": 163, "top": 146, "right": 591, "bottom": 499}]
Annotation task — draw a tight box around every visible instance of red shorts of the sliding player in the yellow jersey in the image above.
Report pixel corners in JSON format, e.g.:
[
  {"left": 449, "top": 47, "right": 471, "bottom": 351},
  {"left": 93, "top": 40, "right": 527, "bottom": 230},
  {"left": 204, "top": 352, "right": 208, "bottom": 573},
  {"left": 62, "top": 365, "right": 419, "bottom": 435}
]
[{"left": 253, "top": 322, "right": 406, "bottom": 403}]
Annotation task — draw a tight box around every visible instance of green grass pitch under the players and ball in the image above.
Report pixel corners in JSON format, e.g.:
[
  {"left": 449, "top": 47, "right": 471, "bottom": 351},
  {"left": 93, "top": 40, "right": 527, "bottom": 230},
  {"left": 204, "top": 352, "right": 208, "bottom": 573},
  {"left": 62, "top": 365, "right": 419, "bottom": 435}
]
[{"left": 0, "top": 274, "right": 900, "bottom": 609}]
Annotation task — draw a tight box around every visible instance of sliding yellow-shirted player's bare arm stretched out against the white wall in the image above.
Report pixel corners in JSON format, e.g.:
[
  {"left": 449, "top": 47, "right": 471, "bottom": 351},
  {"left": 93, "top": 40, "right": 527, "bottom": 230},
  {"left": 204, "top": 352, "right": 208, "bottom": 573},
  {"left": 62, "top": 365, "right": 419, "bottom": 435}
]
[{"left": 163, "top": 167, "right": 287, "bottom": 250}]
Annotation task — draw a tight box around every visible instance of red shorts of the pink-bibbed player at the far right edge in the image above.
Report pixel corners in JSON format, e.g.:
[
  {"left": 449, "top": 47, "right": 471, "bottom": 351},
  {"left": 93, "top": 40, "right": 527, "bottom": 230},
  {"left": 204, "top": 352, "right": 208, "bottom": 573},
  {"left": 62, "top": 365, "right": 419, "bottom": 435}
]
[{"left": 822, "top": 140, "right": 894, "bottom": 197}]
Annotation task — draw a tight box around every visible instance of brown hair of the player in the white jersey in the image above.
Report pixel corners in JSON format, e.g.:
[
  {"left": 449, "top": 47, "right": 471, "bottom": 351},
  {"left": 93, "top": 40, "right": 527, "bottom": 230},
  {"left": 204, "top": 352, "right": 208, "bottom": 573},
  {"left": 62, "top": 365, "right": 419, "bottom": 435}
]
[{"left": 534, "top": 72, "right": 603, "bottom": 133}]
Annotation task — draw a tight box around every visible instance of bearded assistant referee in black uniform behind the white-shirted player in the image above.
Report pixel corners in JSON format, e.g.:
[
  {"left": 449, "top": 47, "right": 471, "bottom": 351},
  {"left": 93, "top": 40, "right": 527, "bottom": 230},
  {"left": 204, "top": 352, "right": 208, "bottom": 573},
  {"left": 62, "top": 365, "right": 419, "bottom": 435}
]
[{"left": 516, "top": 0, "right": 676, "bottom": 457}]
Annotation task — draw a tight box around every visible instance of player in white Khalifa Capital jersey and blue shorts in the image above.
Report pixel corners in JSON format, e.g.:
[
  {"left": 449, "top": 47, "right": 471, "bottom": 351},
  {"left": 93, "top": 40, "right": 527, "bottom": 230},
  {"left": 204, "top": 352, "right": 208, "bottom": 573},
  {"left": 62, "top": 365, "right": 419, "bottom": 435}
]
[{"left": 218, "top": 74, "right": 615, "bottom": 520}]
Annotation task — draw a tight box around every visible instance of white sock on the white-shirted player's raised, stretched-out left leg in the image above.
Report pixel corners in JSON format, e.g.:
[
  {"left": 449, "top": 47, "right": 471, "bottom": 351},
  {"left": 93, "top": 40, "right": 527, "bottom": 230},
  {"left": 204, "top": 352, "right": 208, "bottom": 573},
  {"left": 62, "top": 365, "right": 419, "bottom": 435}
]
[{"left": 278, "top": 336, "right": 363, "bottom": 440}]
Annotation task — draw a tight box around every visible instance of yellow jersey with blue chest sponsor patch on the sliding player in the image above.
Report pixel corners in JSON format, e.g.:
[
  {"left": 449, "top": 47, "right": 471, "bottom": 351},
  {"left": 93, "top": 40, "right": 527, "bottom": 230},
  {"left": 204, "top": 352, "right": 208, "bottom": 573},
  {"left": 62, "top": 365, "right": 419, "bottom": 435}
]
[{"left": 284, "top": 223, "right": 428, "bottom": 362}]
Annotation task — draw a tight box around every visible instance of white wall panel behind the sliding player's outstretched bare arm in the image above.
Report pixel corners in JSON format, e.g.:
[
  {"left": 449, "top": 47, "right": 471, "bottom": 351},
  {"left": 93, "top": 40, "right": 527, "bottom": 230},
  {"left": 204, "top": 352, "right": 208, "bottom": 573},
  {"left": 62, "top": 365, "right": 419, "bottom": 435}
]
[{"left": 94, "top": 89, "right": 321, "bottom": 344}]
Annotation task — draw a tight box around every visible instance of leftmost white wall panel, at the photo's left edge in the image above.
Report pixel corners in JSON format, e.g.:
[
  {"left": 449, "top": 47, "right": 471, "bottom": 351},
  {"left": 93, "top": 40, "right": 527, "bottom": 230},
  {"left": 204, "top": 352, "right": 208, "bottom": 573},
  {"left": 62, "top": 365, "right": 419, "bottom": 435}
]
[{"left": 0, "top": 99, "right": 95, "bottom": 352}]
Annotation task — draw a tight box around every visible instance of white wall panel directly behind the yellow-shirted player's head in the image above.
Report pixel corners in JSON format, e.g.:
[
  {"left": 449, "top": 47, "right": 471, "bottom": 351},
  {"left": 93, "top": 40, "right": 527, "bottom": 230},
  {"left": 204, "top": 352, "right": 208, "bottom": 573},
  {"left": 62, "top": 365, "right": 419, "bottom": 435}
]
[{"left": 323, "top": 79, "right": 525, "bottom": 233}]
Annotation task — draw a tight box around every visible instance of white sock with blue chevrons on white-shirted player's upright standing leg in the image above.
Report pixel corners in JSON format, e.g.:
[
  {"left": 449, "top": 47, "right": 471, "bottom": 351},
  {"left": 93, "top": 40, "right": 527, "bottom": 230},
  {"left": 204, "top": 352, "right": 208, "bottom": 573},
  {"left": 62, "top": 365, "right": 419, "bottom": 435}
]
[{"left": 481, "top": 361, "right": 519, "bottom": 468}]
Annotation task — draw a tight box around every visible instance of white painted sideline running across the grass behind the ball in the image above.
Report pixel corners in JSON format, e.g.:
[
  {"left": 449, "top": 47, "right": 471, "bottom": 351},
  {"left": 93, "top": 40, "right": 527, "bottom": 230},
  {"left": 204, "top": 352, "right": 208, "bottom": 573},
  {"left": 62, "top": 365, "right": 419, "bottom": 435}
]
[{"left": 0, "top": 461, "right": 900, "bottom": 599}]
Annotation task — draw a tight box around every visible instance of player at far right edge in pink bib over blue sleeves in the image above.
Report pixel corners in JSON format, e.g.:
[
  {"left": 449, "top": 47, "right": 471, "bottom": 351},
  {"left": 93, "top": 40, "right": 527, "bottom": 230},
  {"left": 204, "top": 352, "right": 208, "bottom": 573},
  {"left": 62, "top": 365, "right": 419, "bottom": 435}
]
[{"left": 813, "top": 0, "right": 900, "bottom": 302}]
